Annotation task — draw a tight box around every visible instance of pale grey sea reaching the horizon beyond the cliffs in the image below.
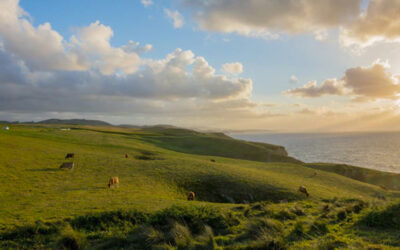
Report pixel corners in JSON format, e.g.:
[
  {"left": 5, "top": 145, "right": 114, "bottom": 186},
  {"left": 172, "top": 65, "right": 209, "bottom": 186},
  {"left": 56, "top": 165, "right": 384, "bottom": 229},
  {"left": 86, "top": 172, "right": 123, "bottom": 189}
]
[{"left": 230, "top": 132, "right": 400, "bottom": 173}]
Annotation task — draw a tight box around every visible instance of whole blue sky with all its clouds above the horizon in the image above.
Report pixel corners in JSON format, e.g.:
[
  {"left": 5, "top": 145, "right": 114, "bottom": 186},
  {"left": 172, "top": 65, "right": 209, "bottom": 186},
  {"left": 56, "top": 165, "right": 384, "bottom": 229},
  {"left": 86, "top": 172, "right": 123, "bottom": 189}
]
[{"left": 0, "top": 0, "right": 400, "bottom": 132}]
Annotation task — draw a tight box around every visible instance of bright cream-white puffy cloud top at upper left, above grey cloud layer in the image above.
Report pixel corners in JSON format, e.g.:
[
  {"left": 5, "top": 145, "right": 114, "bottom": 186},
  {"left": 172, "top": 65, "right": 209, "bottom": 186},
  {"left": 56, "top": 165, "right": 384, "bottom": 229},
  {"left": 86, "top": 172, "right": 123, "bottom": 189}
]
[{"left": 0, "top": 0, "right": 151, "bottom": 75}]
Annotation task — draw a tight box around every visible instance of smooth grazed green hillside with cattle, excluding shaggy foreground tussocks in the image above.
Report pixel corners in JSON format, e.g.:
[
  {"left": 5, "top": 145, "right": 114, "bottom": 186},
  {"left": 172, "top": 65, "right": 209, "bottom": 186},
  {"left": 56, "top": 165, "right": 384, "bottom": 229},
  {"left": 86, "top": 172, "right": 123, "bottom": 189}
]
[{"left": 0, "top": 126, "right": 399, "bottom": 248}]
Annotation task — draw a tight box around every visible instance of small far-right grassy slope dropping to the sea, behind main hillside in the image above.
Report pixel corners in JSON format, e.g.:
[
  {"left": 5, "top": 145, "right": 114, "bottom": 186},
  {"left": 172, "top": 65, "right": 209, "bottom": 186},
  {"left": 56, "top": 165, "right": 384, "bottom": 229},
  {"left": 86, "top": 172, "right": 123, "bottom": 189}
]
[{"left": 306, "top": 163, "right": 400, "bottom": 190}]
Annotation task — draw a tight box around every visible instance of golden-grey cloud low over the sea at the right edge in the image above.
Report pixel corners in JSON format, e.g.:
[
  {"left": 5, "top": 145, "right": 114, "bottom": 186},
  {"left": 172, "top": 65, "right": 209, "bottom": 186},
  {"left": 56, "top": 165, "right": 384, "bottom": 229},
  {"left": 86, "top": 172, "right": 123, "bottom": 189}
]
[{"left": 284, "top": 60, "right": 400, "bottom": 101}]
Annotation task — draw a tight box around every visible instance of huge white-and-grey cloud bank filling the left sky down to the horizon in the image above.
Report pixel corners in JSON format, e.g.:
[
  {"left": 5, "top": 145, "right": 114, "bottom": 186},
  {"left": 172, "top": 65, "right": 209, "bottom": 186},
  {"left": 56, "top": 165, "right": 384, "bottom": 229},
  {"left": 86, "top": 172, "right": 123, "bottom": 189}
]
[{"left": 0, "top": 0, "right": 267, "bottom": 126}]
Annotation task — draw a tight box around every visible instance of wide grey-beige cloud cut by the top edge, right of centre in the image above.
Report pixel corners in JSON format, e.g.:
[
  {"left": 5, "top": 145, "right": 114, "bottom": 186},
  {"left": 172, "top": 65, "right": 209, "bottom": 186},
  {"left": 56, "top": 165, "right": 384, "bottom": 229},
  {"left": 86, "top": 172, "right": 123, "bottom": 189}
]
[{"left": 181, "top": 0, "right": 361, "bottom": 39}]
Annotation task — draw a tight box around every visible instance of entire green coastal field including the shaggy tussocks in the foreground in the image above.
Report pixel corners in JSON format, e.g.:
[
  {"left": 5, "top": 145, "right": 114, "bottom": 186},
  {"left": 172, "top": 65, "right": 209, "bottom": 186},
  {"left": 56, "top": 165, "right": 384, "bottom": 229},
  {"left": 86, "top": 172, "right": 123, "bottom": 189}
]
[{"left": 0, "top": 124, "right": 400, "bottom": 249}]
